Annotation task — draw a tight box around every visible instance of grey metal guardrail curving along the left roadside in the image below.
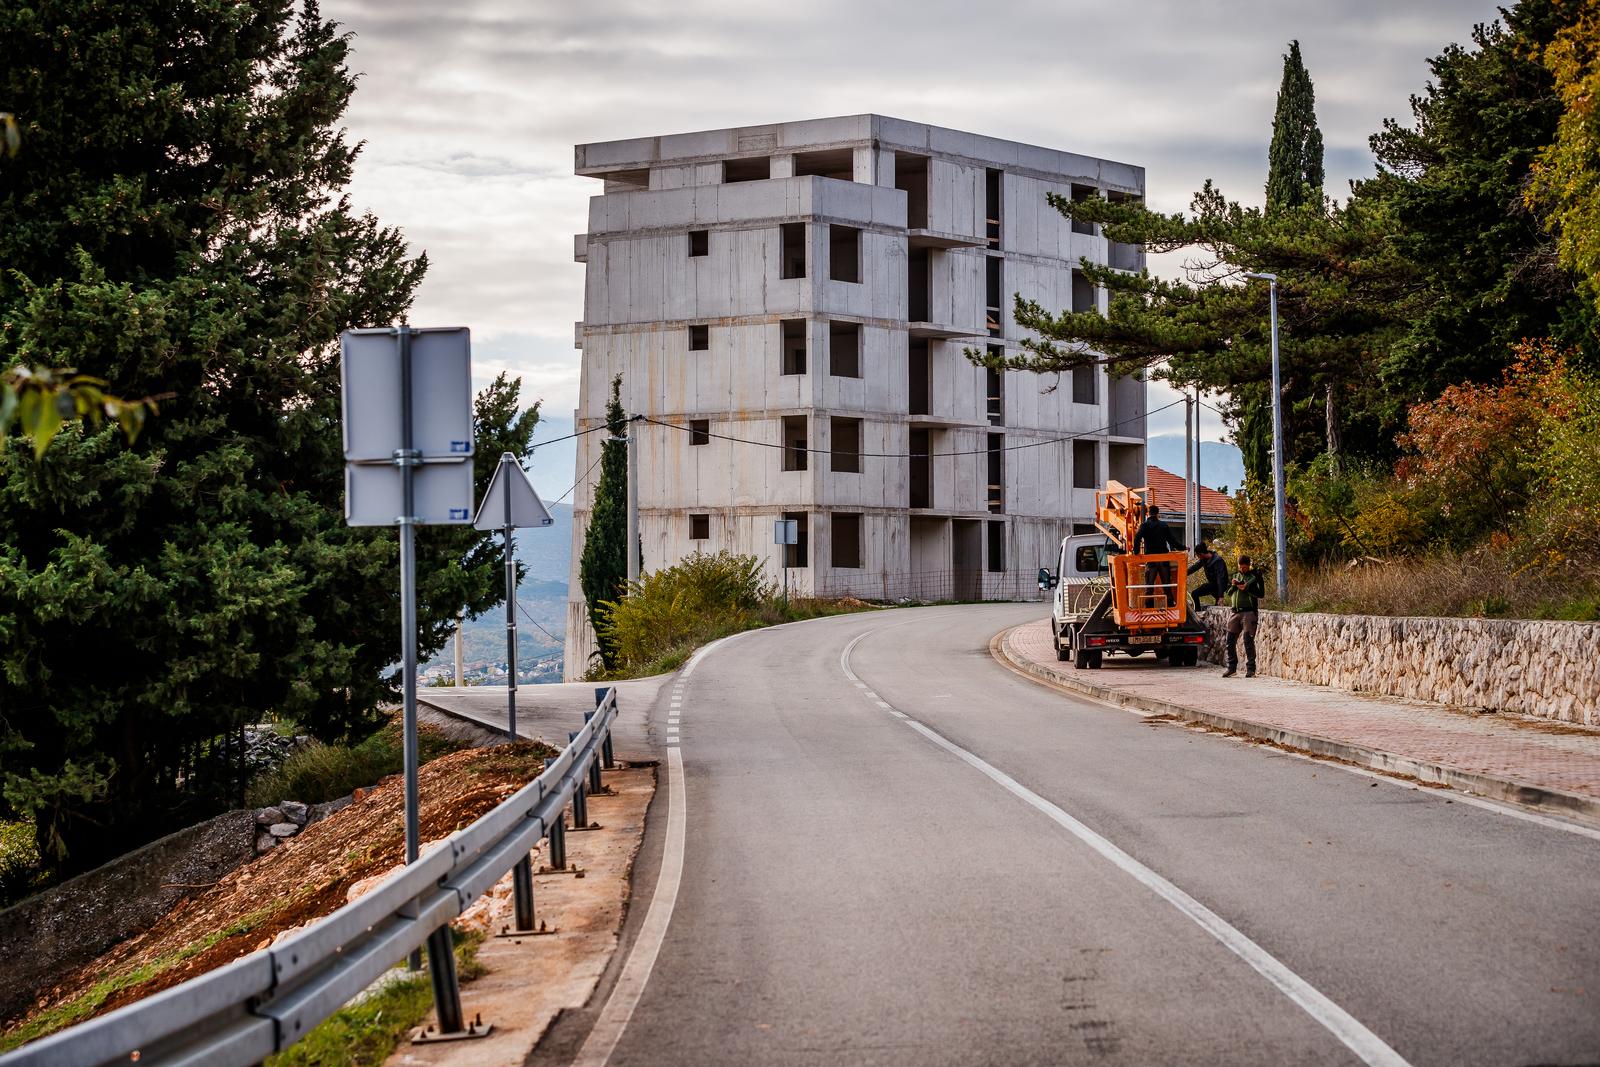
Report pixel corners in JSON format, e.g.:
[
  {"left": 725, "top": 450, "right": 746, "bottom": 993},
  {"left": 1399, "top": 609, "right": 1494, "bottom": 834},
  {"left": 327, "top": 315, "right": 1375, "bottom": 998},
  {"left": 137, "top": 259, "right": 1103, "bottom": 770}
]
[{"left": 0, "top": 688, "right": 618, "bottom": 1067}]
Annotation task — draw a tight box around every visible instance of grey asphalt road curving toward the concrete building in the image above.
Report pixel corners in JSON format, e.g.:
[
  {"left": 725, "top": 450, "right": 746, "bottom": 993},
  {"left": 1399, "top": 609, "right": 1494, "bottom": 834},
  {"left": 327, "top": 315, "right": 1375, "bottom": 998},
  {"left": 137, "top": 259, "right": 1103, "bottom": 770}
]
[{"left": 530, "top": 606, "right": 1600, "bottom": 1067}]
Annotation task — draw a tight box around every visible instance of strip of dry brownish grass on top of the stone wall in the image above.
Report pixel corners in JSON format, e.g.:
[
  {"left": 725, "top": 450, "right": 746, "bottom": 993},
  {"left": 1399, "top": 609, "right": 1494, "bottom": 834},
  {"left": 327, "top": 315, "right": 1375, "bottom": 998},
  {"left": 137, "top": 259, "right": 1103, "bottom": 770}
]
[{"left": 1286, "top": 549, "right": 1600, "bottom": 621}]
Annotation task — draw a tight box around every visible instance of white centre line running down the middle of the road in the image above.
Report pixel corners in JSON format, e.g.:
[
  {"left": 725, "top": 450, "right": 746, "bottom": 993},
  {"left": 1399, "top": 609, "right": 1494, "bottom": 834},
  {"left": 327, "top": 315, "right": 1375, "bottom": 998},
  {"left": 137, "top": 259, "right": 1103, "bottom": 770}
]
[{"left": 838, "top": 633, "right": 1410, "bottom": 1067}]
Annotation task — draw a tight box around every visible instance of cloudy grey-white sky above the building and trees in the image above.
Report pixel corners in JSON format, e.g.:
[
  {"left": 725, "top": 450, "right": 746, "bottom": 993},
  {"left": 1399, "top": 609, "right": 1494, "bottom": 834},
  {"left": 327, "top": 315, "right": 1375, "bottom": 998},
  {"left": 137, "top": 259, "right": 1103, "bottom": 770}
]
[{"left": 323, "top": 0, "right": 1496, "bottom": 494}]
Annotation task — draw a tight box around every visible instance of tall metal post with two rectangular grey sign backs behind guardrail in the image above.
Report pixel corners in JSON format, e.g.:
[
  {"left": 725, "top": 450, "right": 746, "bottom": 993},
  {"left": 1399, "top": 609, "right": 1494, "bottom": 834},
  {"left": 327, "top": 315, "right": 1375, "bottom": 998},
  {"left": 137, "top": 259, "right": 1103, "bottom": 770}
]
[{"left": 339, "top": 326, "right": 472, "bottom": 1032}]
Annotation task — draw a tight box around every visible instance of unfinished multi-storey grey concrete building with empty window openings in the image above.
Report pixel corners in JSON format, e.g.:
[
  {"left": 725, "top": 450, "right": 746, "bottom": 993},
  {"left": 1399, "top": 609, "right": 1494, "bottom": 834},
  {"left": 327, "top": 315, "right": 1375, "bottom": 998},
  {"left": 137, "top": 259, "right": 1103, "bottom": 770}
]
[{"left": 566, "top": 115, "right": 1146, "bottom": 677}]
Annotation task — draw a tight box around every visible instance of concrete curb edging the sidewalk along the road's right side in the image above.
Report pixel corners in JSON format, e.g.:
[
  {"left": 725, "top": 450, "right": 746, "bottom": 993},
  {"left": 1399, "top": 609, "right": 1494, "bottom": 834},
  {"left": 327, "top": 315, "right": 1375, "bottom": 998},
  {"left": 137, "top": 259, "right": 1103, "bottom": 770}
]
[{"left": 989, "top": 627, "right": 1600, "bottom": 827}]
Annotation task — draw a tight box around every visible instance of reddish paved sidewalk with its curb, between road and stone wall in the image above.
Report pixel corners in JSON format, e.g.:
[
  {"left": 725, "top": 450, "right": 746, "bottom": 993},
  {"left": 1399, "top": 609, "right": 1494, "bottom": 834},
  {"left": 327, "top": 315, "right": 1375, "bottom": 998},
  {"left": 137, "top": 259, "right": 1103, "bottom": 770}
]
[{"left": 994, "top": 619, "right": 1600, "bottom": 824}]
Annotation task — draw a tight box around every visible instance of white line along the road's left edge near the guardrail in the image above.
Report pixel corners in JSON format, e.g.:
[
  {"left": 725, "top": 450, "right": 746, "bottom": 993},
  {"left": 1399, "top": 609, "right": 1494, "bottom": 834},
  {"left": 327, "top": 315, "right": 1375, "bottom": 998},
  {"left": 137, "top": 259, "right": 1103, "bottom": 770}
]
[{"left": 573, "top": 630, "right": 754, "bottom": 1067}]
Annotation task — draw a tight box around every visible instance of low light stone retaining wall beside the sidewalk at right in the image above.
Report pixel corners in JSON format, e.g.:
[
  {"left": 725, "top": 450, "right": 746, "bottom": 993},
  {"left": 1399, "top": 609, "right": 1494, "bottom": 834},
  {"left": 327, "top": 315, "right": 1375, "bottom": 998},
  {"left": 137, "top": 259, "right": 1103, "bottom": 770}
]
[{"left": 1203, "top": 608, "right": 1600, "bottom": 726}]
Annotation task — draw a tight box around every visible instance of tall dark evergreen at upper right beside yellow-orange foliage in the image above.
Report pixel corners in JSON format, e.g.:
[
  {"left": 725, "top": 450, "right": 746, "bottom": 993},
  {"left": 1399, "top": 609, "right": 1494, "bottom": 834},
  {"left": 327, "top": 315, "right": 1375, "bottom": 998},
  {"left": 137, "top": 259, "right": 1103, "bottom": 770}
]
[{"left": 1357, "top": 0, "right": 1597, "bottom": 402}]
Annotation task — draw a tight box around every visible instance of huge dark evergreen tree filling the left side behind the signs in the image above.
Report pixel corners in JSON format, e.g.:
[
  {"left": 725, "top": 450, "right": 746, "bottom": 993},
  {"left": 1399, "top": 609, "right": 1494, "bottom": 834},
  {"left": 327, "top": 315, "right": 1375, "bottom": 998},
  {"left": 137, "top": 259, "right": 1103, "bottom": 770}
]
[{"left": 0, "top": 0, "right": 538, "bottom": 870}]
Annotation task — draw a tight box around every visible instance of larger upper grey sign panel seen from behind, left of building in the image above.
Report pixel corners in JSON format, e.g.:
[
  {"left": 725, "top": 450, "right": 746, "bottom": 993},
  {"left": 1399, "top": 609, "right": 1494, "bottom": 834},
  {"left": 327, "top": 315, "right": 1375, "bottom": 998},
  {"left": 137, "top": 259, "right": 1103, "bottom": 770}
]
[{"left": 339, "top": 326, "right": 472, "bottom": 462}]
